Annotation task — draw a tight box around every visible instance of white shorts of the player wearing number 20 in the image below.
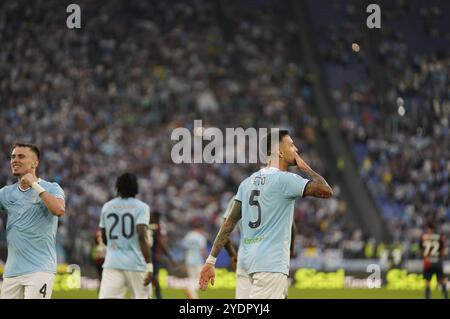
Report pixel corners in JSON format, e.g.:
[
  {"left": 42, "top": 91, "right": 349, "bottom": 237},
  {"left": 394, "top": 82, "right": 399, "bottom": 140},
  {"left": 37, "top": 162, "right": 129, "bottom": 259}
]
[{"left": 98, "top": 268, "right": 152, "bottom": 299}]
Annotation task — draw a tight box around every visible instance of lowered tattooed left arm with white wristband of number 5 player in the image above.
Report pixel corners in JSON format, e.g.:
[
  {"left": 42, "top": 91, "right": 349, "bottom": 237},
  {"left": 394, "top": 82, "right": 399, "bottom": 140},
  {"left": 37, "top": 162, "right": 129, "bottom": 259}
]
[{"left": 199, "top": 200, "right": 242, "bottom": 290}]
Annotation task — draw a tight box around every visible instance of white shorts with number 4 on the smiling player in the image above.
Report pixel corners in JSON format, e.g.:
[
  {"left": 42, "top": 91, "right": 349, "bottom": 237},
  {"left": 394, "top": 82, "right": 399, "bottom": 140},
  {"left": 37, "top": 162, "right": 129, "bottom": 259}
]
[{"left": 0, "top": 272, "right": 55, "bottom": 299}]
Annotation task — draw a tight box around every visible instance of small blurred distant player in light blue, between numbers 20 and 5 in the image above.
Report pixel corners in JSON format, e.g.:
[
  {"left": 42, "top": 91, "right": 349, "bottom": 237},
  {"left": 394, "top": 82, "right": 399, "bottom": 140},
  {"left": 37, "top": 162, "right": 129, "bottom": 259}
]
[{"left": 182, "top": 220, "right": 208, "bottom": 299}]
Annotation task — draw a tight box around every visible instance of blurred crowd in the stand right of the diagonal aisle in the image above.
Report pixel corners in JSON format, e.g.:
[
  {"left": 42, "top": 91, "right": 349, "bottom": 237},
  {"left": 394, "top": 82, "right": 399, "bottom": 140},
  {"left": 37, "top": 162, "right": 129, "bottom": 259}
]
[{"left": 312, "top": 1, "right": 450, "bottom": 258}]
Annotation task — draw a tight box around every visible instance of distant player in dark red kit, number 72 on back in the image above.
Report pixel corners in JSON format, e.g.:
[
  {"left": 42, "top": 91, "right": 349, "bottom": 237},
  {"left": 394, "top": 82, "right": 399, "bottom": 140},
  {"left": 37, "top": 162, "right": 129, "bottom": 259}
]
[{"left": 420, "top": 222, "right": 448, "bottom": 299}]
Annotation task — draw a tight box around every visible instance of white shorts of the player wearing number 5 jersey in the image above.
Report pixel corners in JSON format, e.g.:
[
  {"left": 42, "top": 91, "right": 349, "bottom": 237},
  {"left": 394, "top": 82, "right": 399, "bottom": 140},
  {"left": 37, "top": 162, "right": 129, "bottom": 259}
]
[{"left": 236, "top": 269, "right": 288, "bottom": 299}]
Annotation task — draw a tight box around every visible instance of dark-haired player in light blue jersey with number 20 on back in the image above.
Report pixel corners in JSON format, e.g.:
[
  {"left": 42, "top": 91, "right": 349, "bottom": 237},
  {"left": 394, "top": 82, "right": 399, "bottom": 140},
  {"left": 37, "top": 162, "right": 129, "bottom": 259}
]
[{"left": 99, "top": 173, "right": 153, "bottom": 299}]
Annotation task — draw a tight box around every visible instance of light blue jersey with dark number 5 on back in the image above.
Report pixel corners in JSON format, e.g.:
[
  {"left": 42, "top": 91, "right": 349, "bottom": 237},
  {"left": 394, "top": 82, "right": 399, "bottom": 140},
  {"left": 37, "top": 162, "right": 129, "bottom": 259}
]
[{"left": 235, "top": 167, "right": 309, "bottom": 275}]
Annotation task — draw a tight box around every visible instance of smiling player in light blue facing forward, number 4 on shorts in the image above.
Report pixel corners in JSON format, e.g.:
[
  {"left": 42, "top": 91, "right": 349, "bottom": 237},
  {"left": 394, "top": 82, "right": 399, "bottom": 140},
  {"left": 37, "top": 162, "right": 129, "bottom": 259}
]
[{"left": 0, "top": 143, "right": 65, "bottom": 299}]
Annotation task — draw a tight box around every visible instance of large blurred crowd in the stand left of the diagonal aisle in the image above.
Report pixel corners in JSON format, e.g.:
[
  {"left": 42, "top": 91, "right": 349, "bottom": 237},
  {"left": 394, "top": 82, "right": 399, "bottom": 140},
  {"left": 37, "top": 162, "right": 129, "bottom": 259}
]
[{"left": 0, "top": 1, "right": 353, "bottom": 276}]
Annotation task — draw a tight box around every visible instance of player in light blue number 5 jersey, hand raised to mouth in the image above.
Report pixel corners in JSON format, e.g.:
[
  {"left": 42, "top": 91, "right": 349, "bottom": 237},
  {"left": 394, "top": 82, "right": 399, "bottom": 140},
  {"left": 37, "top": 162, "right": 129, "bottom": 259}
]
[{"left": 199, "top": 131, "right": 333, "bottom": 299}]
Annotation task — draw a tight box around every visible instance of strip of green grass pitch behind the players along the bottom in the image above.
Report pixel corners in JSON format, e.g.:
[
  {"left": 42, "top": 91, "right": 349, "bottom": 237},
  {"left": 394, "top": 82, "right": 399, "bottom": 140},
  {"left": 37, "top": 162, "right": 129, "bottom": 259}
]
[{"left": 52, "top": 288, "right": 442, "bottom": 299}]
